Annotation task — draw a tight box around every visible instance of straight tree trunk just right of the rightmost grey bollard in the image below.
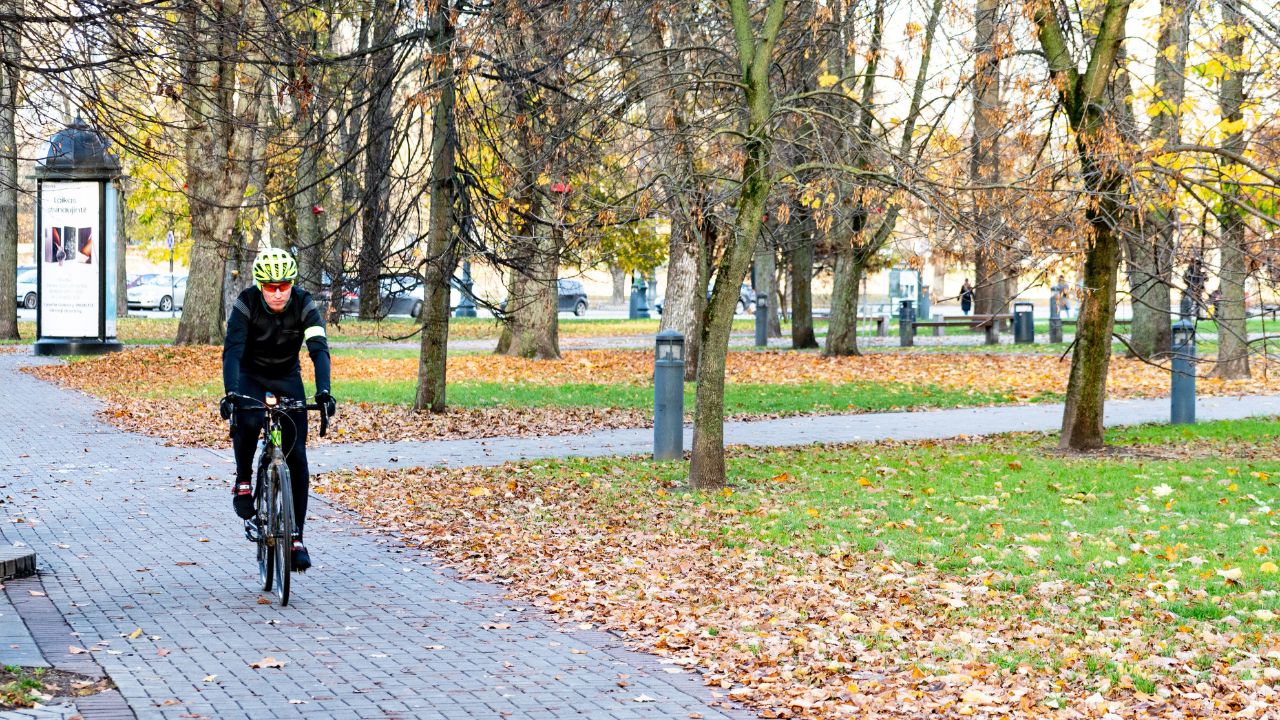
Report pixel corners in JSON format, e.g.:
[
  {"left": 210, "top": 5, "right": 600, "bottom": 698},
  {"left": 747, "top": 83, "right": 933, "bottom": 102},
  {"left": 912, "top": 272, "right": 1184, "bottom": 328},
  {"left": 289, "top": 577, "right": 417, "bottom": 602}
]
[{"left": 1213, "top": 0, "right": 1249, "bottom": 379}]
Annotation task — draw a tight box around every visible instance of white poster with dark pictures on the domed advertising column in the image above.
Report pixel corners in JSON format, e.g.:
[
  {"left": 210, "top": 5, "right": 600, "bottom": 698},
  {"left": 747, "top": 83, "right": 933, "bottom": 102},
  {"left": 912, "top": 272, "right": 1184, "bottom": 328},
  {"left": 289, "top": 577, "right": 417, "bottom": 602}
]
[{"left": 40, "top": 182, "right": 101, "bottom": 337}]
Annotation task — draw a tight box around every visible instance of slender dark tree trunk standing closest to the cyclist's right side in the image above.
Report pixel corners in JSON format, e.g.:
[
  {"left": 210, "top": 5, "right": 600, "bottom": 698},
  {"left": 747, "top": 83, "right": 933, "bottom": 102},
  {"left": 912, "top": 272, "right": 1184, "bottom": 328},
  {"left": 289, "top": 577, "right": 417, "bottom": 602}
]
[{"left": 413, "top": 8, "right": 458, "bottom": 413}]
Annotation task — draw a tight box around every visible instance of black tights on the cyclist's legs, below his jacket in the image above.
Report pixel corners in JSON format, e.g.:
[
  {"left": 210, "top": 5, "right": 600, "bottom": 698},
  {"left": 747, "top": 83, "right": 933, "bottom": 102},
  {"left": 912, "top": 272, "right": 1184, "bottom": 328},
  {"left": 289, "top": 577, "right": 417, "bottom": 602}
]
[{"left": 232, "top": 373, "right": 311, "bottom": 537}]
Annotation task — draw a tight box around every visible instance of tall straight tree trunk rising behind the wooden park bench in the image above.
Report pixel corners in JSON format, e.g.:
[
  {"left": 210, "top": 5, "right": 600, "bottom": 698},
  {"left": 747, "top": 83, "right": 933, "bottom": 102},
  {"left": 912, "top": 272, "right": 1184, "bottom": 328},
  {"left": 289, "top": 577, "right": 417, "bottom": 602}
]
[{"left": 969, "top": 0, "right": 1009, "bottom": 315}]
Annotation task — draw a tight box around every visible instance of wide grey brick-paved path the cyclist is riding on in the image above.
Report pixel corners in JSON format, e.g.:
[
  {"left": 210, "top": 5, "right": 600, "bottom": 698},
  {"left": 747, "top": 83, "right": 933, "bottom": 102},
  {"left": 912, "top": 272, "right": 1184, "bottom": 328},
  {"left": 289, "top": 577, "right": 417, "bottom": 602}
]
[{"left": 0, "top": 354, "right": 754, "bottom": 720}]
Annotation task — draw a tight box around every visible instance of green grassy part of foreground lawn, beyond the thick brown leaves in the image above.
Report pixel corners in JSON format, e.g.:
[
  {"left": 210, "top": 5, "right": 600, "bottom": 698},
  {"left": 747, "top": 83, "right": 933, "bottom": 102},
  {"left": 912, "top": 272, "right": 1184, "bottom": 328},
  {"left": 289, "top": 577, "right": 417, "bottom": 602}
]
[{"left": 535, "top": 419, "right": 1280, "bottom": 624}]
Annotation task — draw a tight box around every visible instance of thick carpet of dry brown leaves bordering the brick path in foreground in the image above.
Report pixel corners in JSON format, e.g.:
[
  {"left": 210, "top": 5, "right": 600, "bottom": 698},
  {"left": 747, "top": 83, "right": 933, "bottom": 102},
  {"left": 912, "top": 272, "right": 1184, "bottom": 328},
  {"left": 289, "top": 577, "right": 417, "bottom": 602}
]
[{"left": 316, "top": 450, "right": 1280, "bottom": 720}]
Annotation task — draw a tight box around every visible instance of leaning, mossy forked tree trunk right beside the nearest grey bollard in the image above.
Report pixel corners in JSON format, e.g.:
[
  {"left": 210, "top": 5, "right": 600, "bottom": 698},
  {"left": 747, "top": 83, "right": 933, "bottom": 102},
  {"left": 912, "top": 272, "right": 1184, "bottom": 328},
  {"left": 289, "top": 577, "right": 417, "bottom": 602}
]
[{"left": 689, "top": 0, "right": 786, "bottom": 489}]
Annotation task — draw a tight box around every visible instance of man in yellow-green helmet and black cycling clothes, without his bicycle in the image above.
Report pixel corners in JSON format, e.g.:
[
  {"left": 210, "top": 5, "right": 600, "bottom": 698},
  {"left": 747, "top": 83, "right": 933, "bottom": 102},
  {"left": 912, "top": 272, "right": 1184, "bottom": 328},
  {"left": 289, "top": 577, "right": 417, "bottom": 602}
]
[{"left": 219, "top": 247, "right": 337, "bottom": 570}]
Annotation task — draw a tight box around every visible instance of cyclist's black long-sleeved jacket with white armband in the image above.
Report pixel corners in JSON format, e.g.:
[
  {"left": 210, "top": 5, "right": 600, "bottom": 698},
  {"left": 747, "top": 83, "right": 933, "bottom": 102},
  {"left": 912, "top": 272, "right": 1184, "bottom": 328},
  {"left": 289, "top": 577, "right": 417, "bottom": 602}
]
[{"left": 223, "top": 286, "right": 329, "bottom": 392}]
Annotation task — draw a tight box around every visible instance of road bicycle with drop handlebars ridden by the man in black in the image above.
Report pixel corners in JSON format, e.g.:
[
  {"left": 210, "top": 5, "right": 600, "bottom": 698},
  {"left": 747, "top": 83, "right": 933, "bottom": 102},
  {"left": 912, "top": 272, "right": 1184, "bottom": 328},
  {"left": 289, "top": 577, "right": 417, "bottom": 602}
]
[{"left": 232, "top": 392, "right": 329, "bottom": 606}]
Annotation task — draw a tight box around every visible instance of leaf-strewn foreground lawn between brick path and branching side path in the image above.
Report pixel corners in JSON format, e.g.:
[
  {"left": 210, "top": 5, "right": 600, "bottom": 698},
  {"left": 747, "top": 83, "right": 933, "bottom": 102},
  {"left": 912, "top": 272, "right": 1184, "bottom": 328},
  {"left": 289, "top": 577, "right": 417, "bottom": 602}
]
[{"left": 317, "top": 419, "right": 1280, "bottom": 720}]
